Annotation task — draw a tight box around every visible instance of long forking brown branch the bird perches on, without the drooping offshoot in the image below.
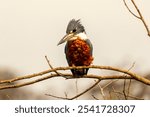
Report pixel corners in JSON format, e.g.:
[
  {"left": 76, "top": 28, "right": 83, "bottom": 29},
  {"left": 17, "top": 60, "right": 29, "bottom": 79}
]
[{"left": 0, "top": 65, "right": 150, "bottom": 90}]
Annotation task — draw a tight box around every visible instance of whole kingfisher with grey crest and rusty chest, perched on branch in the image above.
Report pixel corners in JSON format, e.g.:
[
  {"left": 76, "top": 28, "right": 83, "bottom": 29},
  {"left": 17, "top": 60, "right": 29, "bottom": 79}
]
[{"left": 58, "top": 19, "right": 93, "bottom": 77}]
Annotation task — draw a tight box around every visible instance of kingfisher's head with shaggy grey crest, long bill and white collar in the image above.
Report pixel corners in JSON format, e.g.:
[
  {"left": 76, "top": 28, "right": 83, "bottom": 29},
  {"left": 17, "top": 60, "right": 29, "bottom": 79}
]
[{"left": 58, "top": 19, "right": 87, "bottom": 45}]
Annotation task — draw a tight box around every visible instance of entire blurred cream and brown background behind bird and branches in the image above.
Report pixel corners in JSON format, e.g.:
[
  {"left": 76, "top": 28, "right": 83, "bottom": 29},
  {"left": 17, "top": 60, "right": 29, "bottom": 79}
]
[{"left": 0, "top": 0, "right": 150, "bottom": 99}]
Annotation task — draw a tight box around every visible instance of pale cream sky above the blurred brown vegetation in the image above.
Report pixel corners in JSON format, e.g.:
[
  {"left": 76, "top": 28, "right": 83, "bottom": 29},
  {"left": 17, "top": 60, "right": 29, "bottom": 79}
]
[{"left": 0, "top": 0, "right": 150, "bottom": 97}]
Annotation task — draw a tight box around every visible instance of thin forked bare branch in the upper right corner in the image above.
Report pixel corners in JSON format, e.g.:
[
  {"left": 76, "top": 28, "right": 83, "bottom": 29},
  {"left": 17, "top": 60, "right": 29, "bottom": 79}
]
[{"left": 123, "top": 0, "right": 150, "bottom": 36}]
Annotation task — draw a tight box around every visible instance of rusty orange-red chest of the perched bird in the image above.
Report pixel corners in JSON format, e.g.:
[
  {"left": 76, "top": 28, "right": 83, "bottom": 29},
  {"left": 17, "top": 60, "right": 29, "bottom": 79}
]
[{"left": 66, "top": 39, "right": 91, "bottom": 65}]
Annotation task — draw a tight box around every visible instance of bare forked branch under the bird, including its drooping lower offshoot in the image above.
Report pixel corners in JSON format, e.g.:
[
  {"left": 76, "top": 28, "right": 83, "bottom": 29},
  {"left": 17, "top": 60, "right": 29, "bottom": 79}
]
[{"left": 0, "top": 65, "right": 150, "bottom": 100}]
